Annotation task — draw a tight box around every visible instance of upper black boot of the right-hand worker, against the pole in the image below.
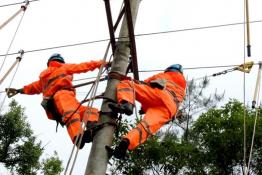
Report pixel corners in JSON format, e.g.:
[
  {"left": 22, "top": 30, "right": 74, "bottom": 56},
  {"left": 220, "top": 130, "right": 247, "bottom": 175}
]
[{"left": 108, "top": 101, "right": 134, "bottom": 115}]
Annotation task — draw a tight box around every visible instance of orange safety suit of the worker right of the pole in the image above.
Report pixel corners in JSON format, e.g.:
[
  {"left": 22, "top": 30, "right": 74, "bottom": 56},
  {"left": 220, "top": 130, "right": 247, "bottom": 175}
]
[{"left": 117, "top": 72, "right": 186, "bottom": 150}]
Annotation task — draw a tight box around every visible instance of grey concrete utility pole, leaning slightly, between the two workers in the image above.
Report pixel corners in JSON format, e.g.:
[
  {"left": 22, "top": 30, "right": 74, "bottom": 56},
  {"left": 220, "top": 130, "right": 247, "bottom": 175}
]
[{"left": 85, "top": 0, "right": 141, "bottom": 175}]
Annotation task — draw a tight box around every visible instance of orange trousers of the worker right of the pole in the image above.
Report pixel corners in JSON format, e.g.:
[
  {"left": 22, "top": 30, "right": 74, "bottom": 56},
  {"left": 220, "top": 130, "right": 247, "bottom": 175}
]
[{"left": 117, "top": 80, "right": 177, "bottom": 150}]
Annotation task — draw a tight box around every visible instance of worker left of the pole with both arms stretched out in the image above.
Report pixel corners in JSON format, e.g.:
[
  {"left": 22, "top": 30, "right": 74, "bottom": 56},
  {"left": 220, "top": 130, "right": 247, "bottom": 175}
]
[{"left": 7, "top": 54, "right": 105, "bottom": 149}]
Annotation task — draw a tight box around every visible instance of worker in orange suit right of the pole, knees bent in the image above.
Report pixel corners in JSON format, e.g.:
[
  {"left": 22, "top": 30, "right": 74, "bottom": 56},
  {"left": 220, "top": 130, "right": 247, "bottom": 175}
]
[{"left": 109, "top": 64, "right": 186, "bottom": 159}]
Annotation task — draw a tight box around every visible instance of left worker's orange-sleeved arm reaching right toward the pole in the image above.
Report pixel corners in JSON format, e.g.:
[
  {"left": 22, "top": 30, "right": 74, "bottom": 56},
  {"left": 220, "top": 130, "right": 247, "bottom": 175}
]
[{"left": 64, "top": 60, "right": 106, "bottom": 74}]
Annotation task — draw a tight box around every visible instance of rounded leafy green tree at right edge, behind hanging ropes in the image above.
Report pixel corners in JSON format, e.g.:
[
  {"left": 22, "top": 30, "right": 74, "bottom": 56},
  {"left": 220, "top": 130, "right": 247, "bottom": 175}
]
[{"left": 191, "top": 100, "right": 262, "bottom": 174}]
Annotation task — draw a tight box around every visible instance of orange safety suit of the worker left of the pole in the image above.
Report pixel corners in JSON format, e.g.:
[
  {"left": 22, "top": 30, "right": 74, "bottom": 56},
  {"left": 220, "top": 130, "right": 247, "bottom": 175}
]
[{"left": 23, "top": 61, "right": 104, "bottom": 143}]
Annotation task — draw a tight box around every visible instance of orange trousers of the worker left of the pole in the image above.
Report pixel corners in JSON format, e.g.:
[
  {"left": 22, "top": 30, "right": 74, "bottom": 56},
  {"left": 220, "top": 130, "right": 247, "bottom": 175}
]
[{"left": 54, "top": 90, "right": 99, "bottom": 143}]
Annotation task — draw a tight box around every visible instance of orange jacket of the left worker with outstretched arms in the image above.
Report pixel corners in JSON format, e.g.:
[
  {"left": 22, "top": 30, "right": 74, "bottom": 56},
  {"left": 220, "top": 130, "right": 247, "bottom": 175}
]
[{"left": 23, "top": 61, "right": 104, "bottom": 97}]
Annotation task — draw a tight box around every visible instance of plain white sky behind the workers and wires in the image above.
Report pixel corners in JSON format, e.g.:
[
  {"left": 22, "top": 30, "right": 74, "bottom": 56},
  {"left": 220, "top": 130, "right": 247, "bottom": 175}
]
[{"left": 0, "top": 0, "right": 262, "bottom": 174}]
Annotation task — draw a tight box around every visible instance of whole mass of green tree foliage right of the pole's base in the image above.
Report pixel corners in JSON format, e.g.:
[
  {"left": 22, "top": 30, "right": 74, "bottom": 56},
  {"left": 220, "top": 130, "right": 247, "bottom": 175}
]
[{"left": 111, "top": 96, "right": 262, "bottom": 175}]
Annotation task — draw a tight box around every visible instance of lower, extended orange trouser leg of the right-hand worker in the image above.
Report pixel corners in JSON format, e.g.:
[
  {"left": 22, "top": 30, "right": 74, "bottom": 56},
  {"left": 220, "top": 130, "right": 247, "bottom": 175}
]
[{"left": 124, "top": 106, "right": 172, "bottom": 150}]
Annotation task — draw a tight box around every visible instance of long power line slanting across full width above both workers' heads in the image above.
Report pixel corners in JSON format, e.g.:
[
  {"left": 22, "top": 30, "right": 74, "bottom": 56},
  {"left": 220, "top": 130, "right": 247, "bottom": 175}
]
[{"left": 0, "top": 20, "right": 262, "bottom": 57}]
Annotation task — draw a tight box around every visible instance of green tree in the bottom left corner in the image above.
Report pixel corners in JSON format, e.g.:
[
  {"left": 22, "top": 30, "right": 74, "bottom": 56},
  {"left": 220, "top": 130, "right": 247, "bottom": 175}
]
[{"left": 0, "top": 100, "right": 62, "bottom": 175}]
